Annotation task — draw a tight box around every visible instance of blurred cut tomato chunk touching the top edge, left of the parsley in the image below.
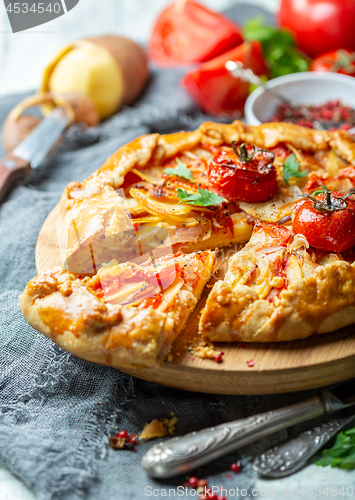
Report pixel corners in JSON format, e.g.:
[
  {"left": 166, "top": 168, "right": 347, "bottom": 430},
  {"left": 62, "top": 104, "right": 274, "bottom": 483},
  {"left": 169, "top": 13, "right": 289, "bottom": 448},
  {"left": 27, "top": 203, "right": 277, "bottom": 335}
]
[{"left": 149, "top": 0, "right": 243, "bottom": 65}]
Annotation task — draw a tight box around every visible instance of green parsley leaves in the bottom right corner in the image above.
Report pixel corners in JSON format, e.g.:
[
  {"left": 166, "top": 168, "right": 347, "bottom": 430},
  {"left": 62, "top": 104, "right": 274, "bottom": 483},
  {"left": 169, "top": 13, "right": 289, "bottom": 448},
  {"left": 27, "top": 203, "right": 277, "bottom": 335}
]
[{"left": 315, "top": 427, "right": 355, "bottom": 470}]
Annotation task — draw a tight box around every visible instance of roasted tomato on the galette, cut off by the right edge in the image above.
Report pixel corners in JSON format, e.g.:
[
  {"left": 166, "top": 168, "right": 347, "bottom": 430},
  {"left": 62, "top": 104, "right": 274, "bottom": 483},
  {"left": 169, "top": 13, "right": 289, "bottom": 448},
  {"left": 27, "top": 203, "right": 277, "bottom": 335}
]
[{"left": 292, "top": 189, "right": 355, "bottom": 252}]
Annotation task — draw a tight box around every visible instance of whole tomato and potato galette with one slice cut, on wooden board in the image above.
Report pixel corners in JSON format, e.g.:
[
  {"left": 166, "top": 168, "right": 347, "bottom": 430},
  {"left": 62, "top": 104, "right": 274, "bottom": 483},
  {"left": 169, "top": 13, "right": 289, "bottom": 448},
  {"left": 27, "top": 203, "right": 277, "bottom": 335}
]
[{"left": 21, "top": 121, "right": 355, "bottom": 367}]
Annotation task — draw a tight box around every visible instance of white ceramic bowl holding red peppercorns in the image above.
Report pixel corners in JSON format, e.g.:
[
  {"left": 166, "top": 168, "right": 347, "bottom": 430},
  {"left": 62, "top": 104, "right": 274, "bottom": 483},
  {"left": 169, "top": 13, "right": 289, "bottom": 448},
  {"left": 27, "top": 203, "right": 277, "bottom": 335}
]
[{"left": 245, "top": 71, "right": 355, "bottom": 125}]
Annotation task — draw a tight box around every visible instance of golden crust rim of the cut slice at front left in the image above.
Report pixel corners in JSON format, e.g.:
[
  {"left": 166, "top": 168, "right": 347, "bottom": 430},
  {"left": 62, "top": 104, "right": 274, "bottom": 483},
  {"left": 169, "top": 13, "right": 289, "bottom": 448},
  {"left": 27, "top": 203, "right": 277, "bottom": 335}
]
[{"left": 20, "top": 250, "right": 215, "bottom": 368}]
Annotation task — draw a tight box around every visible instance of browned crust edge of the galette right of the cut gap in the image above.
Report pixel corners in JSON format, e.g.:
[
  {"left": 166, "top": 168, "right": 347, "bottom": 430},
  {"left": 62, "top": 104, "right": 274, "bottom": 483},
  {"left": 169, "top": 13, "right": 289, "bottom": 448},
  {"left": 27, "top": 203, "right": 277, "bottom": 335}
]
[{"left": 199, "top": 261, "right": 355, "bottom": 342}]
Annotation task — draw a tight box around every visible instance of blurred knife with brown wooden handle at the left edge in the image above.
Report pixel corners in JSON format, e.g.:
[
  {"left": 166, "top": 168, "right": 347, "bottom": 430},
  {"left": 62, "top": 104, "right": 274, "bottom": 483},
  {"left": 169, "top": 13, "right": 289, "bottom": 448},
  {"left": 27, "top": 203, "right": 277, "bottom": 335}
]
[{"left": 0, "top": 107, "right": 69, "bottom": 203}]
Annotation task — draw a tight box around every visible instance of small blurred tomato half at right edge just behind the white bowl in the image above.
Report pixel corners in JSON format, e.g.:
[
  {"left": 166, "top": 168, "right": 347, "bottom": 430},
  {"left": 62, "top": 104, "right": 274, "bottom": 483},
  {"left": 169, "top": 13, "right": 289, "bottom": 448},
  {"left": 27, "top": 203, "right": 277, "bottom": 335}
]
[{"left": 309, "top": 49, "right": 355, "bottom": 76}]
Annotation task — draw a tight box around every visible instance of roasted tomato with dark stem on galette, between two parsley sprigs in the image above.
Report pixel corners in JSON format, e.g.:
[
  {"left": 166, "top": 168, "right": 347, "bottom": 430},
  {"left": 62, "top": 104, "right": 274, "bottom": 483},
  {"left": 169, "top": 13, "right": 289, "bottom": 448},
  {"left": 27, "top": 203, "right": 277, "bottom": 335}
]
[{"left": 208, "top": 143, "right": 278, "bottom": 202}]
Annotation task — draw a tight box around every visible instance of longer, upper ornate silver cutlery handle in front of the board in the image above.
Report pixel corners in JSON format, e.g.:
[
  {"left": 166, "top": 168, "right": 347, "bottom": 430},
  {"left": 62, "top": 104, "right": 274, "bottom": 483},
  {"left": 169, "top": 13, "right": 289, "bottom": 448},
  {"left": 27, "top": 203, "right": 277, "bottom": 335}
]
[{"left": 142, "top": 396, "right": 327, "bottom": 478}]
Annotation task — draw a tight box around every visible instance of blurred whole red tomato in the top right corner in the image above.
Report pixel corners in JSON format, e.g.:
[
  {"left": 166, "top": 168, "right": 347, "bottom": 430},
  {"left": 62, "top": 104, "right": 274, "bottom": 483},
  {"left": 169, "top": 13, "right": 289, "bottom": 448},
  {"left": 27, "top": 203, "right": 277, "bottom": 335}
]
[{"left": 279, "top": 0, "right": 355, "bottom": 57}]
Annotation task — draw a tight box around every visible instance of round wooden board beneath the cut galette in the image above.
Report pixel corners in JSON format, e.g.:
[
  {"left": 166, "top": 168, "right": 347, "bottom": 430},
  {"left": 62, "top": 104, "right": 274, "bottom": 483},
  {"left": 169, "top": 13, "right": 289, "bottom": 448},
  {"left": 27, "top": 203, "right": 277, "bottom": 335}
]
[{"left": 36, "top": 205, "right": 355, "bottom": 394}]
